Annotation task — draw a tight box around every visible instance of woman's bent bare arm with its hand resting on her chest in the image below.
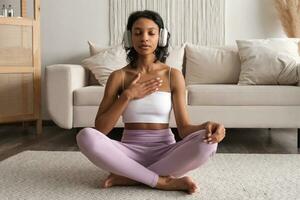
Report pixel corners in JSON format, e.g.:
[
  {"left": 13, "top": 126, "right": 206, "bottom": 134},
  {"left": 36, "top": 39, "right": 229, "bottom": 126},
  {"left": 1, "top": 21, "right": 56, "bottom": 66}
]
[{"left": 95, "top": 70, "right": 161, "bottom": 134}]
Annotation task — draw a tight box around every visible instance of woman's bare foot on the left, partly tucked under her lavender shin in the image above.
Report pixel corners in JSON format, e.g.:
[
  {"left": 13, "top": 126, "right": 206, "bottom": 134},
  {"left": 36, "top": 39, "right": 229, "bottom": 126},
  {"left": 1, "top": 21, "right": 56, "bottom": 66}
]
[{"left": 101, "top": 173, "right": 141, "bottom": 188}]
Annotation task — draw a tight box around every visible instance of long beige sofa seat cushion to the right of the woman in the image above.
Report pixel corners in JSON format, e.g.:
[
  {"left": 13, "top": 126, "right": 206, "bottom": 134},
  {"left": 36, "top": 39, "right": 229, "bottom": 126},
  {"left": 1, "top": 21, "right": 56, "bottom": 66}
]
[{"left": 187, "top": 84, "right": 300, "bottom": 106}]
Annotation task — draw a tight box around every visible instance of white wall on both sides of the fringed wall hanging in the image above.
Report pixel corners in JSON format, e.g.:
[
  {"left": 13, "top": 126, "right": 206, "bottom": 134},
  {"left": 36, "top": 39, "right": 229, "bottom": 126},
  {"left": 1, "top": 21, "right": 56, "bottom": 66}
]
[{"left": 41, "top": 0, "right": 285, "bottom": 119}]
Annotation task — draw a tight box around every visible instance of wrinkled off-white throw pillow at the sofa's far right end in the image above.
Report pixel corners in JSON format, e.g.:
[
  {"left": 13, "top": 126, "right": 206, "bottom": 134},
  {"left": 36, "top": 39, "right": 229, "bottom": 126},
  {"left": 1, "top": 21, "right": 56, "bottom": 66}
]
[{"left": 236, "top": 38, "right": 299, "bottom": 85}]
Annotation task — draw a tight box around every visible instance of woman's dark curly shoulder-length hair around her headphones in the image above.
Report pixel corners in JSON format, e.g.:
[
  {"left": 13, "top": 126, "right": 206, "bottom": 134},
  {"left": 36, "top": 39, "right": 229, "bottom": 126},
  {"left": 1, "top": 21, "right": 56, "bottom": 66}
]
[{"left": 124, "top": 10, "right": 170, "bottom": 66}]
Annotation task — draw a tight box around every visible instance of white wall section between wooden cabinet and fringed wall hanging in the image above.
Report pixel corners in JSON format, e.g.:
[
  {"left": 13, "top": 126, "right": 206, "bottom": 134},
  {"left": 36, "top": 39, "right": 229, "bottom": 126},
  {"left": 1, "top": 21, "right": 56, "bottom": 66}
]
[{"left": 41, "top": 0, "right": 109, "bottom": 119}]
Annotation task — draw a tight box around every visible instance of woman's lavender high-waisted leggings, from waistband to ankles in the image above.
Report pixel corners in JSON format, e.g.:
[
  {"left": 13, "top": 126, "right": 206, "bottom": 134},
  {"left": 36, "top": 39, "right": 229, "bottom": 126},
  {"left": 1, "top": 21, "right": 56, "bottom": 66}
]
[{"left": 77, "top": 128, "right": 217, "bottom": 187}]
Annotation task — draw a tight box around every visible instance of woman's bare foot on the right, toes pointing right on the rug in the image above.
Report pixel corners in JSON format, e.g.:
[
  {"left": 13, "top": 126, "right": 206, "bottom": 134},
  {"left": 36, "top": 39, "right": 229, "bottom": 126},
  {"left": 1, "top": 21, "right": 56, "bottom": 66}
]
[{"left": 156, "top": 176, "right": 198, "bottom": 194}]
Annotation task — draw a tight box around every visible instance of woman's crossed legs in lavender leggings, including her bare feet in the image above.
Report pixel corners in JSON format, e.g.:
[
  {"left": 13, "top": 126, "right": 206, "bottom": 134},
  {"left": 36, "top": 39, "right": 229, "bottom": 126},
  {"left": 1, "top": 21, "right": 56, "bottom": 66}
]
[{"left": 77, "top": 128, "right": 217, "bottom": 192}]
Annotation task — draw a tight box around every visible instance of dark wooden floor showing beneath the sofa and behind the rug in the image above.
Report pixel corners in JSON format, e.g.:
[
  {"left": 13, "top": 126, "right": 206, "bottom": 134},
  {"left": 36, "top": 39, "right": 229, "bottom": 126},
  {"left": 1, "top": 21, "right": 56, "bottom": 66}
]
[{"left": 0, "top": 124, "right": 300, "bottom": 161}]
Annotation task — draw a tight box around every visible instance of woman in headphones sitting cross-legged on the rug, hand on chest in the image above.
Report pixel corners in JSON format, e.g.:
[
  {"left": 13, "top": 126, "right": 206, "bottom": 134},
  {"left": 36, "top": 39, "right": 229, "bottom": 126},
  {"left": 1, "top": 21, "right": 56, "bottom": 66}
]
[{"left": 77, "top": 10, "right": 225, "bottom": 194}]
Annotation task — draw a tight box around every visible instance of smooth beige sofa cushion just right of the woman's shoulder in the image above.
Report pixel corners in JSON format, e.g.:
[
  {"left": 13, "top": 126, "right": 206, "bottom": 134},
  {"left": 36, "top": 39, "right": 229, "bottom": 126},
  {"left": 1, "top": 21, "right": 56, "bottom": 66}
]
[{"left": 185, "top": 44, "right": 240, "bottom": 85}]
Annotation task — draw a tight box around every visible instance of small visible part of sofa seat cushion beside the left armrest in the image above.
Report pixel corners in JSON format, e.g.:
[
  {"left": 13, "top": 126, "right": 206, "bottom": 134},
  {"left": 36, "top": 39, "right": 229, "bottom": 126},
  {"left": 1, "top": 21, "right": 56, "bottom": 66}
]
[{"left": 73, "top": 85, "right": 104, "bottom": 106}]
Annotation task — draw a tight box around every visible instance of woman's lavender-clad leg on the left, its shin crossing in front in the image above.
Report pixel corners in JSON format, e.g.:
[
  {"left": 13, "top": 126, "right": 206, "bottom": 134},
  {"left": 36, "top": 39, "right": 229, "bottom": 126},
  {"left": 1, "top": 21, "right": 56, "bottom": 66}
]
[{"left": 76, "top": 128, "right": 158, "bottom": 187}]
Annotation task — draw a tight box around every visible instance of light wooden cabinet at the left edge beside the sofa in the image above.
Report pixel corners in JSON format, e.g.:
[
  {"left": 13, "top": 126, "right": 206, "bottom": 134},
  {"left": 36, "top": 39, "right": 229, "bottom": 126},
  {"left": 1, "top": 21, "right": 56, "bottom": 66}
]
[{"left": 0, "top": 0, "right": 42, "bottom": 134}]
